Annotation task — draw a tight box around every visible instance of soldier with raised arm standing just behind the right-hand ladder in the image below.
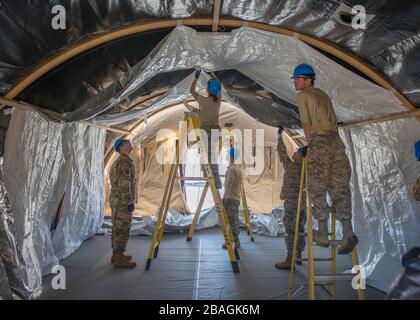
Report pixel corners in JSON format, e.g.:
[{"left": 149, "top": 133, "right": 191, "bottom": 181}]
[{"left": 275, "top": 127, "right": 306, "bottom": 270}]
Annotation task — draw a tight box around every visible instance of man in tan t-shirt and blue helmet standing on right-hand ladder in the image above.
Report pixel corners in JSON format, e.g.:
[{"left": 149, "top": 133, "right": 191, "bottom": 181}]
[{"left": 292, "top": 64, "right": 358, "bottom": 254}]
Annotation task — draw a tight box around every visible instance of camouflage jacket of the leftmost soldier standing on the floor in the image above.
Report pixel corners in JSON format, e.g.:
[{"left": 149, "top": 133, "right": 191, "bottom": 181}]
[{"left": 109, "top": 155, "right": 137, "bottom": 207}]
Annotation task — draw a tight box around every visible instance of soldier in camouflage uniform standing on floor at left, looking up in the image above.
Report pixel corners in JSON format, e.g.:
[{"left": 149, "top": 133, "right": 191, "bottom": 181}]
[{"left": 109, "top": 139, "right": 137, "bottom": 268}]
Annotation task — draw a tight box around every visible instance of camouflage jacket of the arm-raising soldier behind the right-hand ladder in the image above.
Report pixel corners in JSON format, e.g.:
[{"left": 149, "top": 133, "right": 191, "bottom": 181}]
[{"left": 277, "top": 136, "right": 302, "bottom": 200}]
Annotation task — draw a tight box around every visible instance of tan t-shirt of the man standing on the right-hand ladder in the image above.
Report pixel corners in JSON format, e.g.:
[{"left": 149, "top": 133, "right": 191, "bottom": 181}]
[{"left": 296, "top": 87, "right": 337, "bottom": 134}]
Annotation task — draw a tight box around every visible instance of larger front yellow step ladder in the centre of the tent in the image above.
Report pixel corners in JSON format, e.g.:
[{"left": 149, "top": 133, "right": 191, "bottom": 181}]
[{"left": 145, "top": 112, "right": 240, "bottom": 273}]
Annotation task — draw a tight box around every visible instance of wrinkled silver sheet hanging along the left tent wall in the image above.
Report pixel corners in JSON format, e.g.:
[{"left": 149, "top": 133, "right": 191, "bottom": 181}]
[{"left": 4, "top": 110, "right": 106, "bottom": 297}]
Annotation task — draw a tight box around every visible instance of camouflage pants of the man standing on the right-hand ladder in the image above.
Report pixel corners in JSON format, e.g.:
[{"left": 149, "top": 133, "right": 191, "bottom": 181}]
[{"left": 307, "top": 134, "right": 351, "bottom": 221}]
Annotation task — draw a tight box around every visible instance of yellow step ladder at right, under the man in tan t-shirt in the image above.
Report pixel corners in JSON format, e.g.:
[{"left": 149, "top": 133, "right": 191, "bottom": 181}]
[{"left": 288, "top": 158, "right": 365, "bottom": 300}]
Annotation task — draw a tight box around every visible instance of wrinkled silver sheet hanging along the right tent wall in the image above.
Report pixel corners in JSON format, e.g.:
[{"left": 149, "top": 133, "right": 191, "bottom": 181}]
[{"left": 342, "top": 119, "right": 420, "bottom": 292}]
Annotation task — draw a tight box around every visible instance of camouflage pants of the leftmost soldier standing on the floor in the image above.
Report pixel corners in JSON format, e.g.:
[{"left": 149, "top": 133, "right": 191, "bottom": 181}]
[{"left": 111, "top": 206, "right": 133, "bottom": 253}]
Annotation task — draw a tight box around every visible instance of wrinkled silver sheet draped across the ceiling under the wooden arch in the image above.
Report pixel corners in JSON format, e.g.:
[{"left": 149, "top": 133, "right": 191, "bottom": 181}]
[{"left": 71, "top": 26, "right": 403, "bottom": 124}]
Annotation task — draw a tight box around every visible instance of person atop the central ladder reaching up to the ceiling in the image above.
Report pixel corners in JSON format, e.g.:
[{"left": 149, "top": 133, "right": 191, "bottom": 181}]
[{"left": 185, "top": 71, "right": 222, "bottom": 189}]
